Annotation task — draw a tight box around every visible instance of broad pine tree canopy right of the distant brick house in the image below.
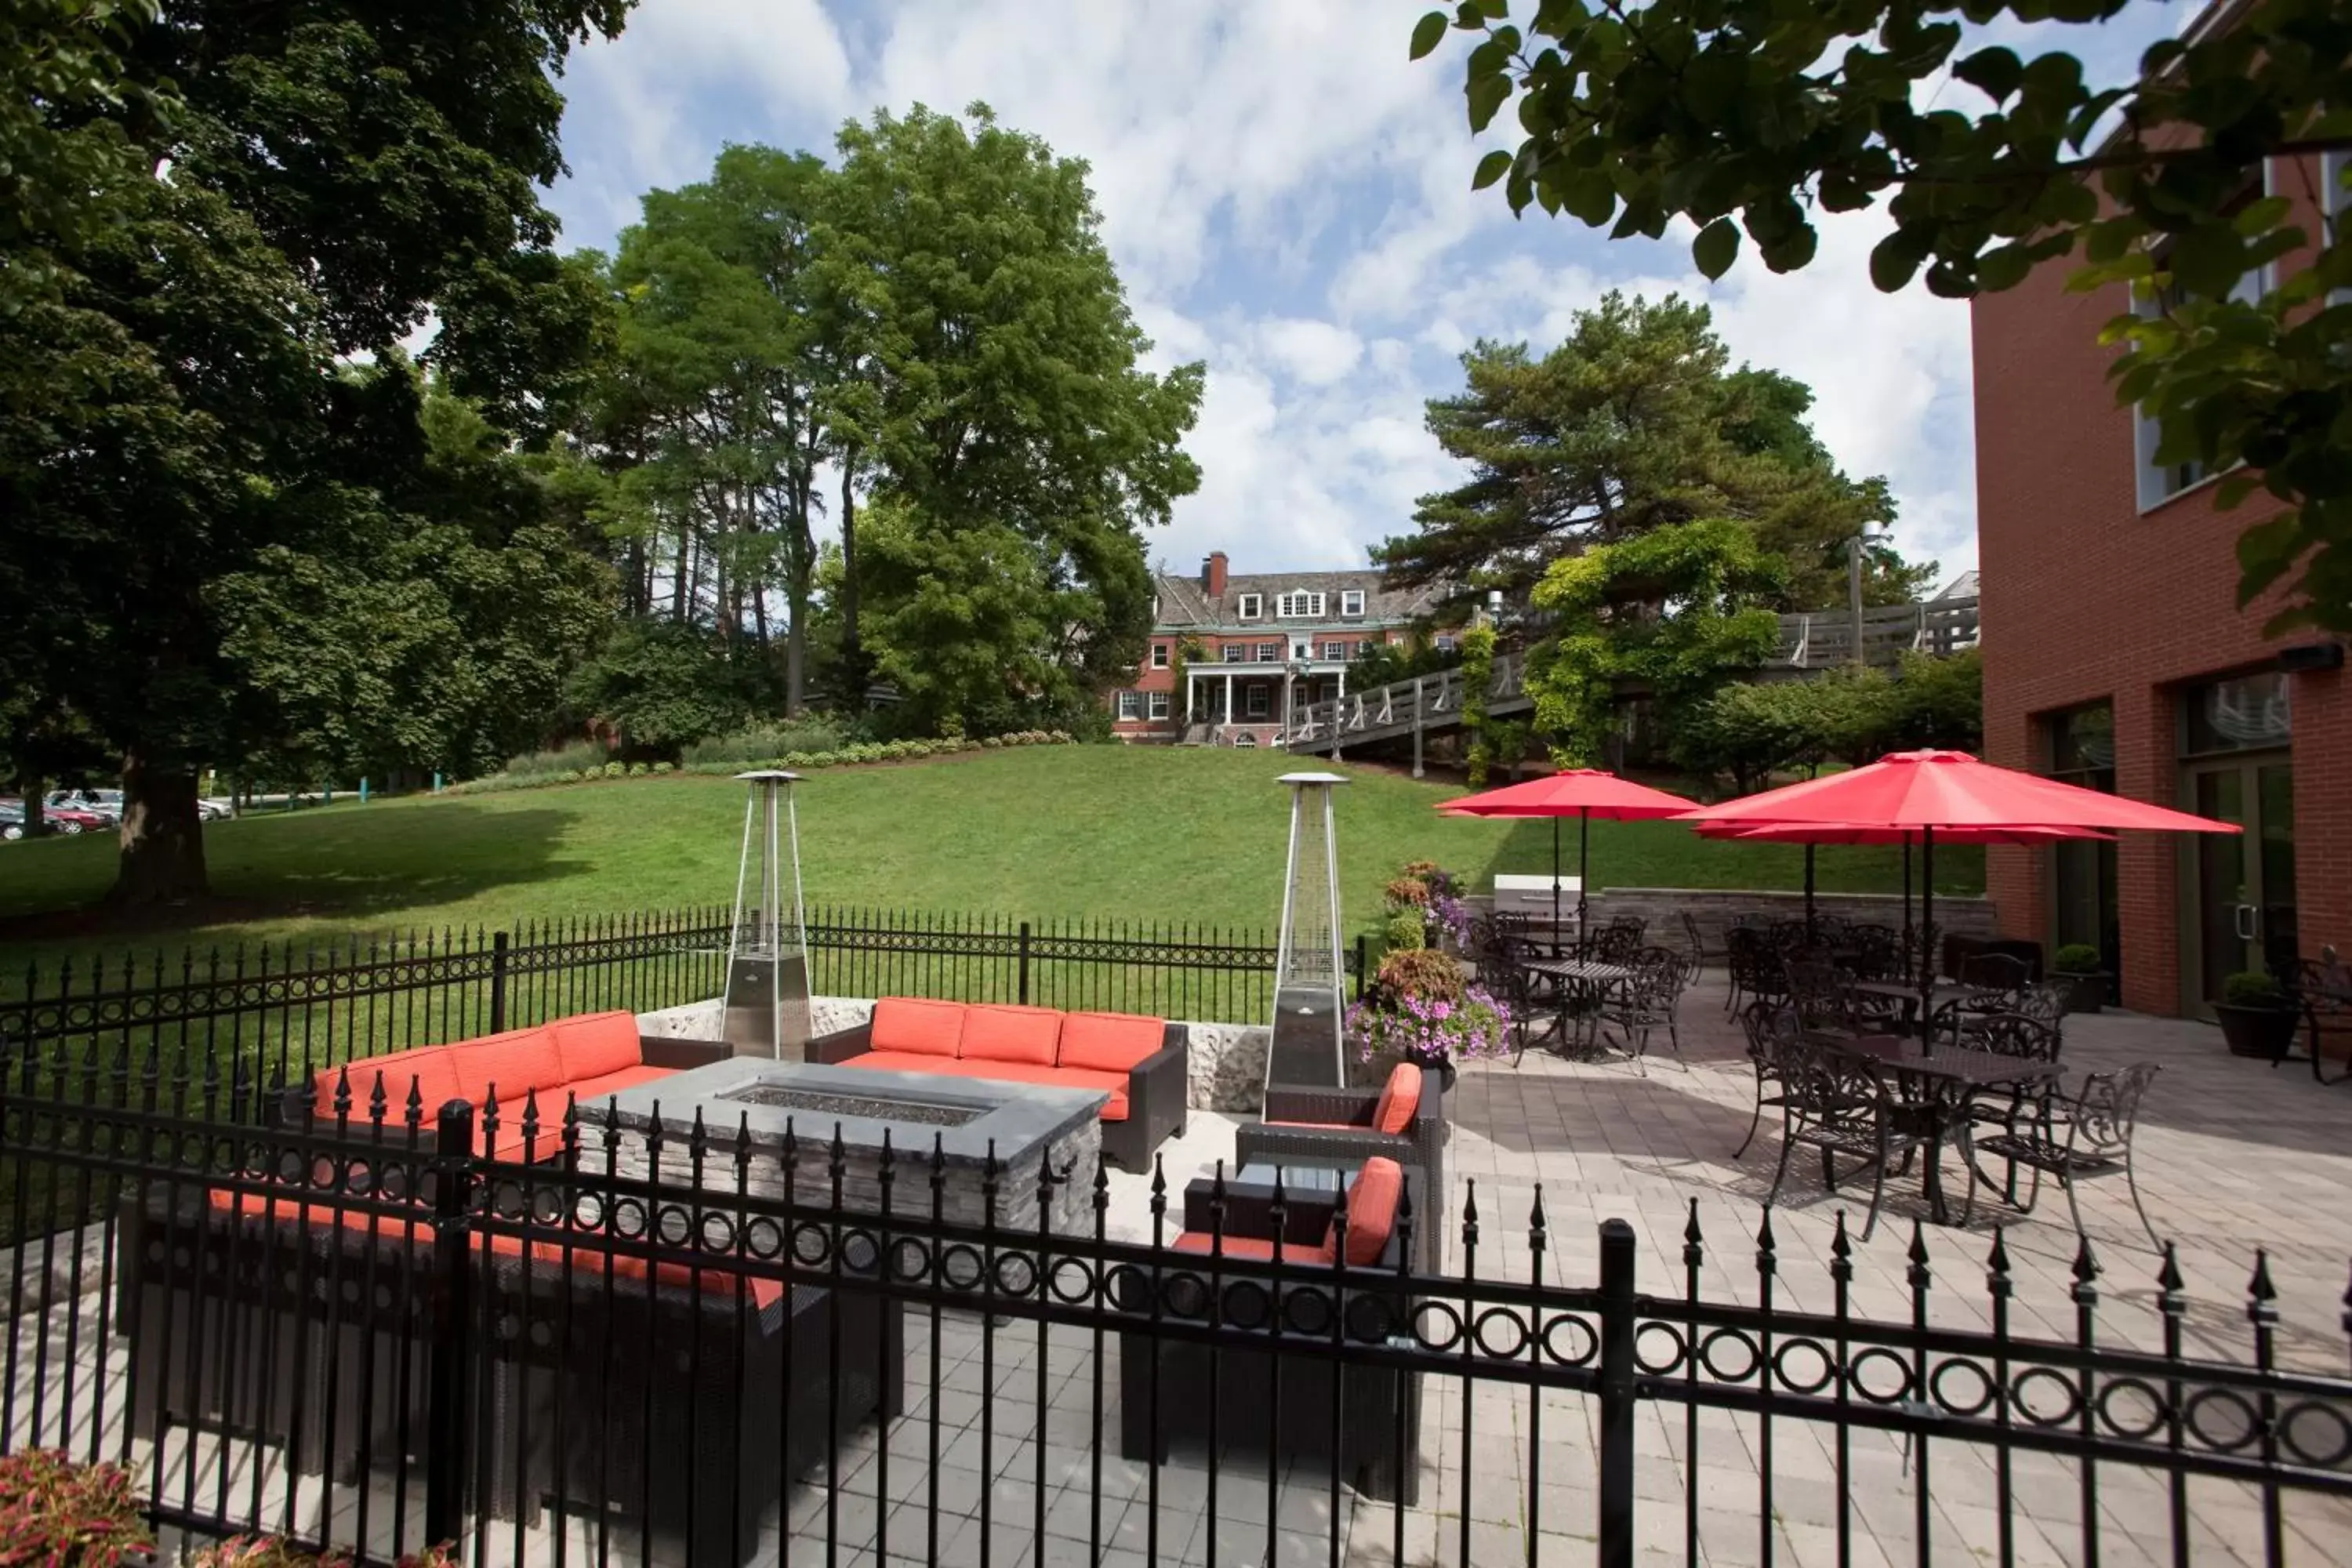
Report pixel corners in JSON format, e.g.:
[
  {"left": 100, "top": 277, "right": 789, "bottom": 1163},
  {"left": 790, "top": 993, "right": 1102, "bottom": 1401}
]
[{"left": 1374, "top": 292, "right": 1922, "bottom": 609}]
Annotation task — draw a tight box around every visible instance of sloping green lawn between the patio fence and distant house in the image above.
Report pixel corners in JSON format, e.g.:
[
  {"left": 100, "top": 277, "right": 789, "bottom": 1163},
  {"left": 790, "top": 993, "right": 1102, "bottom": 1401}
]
[{"left": 0, "top": 746, "right": 1983, "bottom": 961}]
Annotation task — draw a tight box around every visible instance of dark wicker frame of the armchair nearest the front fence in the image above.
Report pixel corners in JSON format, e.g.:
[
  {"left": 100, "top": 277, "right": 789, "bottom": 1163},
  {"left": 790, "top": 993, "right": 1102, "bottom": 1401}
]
[{"left": 1117, "top": 1166, "right": 1425, "bottom": 1507}]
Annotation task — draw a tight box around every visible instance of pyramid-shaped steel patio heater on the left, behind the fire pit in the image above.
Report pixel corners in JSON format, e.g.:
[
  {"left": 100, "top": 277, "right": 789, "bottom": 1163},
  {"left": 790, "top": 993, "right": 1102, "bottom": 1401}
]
[{"left": 720, "top": 769, "right": 809, "bottom": 1060}]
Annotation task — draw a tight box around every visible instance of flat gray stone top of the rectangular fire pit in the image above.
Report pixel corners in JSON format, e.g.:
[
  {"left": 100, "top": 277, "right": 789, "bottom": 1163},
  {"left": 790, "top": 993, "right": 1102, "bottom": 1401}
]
[{"left": 581, "top": 1055, "right": 1110, "bottom": 1163}]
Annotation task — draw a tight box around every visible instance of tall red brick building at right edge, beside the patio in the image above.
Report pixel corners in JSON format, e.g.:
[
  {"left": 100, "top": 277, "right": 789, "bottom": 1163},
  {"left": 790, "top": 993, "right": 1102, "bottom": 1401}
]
[{"left": 1973, "top": 153, "right": 2352, "bottom": 1015}]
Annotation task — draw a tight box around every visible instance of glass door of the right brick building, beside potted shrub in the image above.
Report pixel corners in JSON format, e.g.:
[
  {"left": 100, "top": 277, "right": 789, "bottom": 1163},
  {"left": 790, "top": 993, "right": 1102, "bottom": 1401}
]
[{"left": 2183, "top": 757, "right": 2296, "bottom": 1013}]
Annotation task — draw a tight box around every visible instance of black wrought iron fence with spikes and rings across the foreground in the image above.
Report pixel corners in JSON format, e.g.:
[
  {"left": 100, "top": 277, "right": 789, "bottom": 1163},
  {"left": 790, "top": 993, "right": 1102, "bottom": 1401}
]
[{"left": 0, "top": 1044, "right": 2352, "bottom": 1568}]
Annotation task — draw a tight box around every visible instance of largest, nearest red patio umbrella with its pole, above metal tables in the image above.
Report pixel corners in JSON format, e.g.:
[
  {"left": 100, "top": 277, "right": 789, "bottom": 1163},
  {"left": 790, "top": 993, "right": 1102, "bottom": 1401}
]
[{"left": 1684, "top": 753, "right": 2241, "bottom": 1022}]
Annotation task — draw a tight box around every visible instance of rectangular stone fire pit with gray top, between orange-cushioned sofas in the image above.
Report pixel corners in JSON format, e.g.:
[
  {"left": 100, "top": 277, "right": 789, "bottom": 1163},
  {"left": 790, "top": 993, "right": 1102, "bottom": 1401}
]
[{"left": 583, "top": 1058, "right": 1110, "bottom": 1234}]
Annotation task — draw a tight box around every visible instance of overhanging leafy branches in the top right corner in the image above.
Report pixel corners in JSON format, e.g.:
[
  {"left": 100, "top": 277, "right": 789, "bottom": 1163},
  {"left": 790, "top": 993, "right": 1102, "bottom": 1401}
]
[{"left": 1411, "top": 0, "right": 2352, "bottom": 633}]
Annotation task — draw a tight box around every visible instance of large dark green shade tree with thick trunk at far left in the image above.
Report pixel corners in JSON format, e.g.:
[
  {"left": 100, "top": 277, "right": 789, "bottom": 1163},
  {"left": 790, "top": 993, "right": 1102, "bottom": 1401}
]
[{"left": 0, "top": 0, "right": 628, "bottom": 902}]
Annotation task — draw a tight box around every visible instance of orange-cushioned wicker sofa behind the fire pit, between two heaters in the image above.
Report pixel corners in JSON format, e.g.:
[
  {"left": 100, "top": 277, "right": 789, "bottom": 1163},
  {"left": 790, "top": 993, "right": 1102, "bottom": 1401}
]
[{"left": 809, "top": 996, "right": 1190, "bottom": 1171}]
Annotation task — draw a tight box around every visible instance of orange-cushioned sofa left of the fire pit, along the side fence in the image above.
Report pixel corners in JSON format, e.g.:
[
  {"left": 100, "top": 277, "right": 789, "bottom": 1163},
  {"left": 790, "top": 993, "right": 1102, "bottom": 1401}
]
[{"left": 289, "top": 1013, "right": 729, "bottom": 1159}]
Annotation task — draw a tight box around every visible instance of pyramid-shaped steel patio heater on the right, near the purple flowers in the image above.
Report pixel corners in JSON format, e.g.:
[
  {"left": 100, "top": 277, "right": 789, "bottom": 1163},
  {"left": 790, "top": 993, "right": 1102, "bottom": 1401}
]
[{"left": 1265, "top": 774, "right": 1348, "bottom": 1088}]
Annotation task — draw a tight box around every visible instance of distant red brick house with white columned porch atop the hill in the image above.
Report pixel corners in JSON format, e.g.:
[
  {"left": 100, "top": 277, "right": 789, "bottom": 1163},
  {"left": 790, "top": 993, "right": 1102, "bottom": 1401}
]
[{"left": 1110, "top": 550, "right": 1444, "bottom": 746}]
